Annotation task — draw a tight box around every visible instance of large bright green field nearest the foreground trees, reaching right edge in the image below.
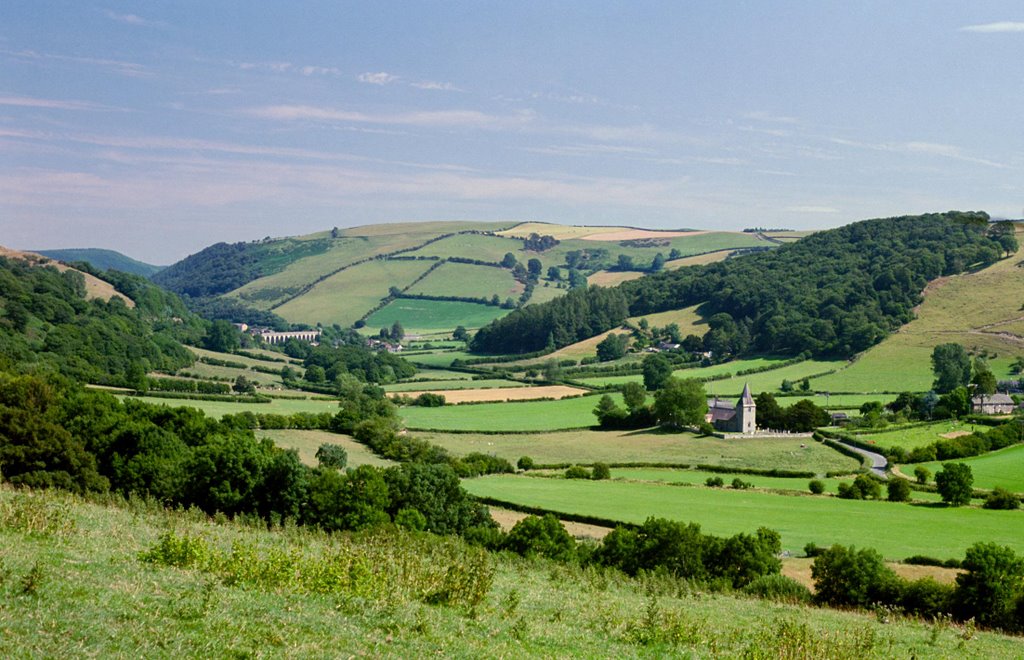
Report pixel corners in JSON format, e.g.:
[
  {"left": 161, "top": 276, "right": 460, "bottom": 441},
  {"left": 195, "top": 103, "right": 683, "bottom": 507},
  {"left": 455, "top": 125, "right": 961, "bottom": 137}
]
[{"left": 464, "top": 475, "right": 1024, "bottom": 560}]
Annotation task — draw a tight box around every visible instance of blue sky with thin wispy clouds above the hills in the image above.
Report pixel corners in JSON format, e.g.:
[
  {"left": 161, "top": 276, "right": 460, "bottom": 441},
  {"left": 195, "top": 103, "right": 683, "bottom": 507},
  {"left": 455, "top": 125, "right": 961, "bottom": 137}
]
[{"left": 0, "top": 0, "right": 1024, "bottom": 265}]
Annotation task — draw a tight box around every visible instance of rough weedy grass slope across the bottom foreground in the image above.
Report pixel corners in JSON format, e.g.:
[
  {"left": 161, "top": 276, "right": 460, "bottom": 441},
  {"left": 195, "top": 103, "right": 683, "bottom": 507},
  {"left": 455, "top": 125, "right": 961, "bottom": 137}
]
[{"left": 0, "top": 482, "right": 1024, "bottom": 659}]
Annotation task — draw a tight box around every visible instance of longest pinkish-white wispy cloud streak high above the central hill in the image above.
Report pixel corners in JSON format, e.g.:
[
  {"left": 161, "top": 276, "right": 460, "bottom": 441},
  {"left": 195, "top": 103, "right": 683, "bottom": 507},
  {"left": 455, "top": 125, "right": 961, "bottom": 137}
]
[{"left": 246, "top": 105, "right": 534, "bottom": 128}]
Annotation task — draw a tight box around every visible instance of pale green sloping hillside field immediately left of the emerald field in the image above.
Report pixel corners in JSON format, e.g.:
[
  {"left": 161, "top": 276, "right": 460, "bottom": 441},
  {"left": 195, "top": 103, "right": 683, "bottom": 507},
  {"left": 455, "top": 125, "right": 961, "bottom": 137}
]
[{"left": 273, "top": 259, "right": 432, "bottom": 327}]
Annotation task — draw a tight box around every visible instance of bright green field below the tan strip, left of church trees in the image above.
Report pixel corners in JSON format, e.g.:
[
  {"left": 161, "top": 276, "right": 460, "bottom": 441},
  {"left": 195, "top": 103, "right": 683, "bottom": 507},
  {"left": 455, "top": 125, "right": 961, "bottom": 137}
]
[{"left": 401, "top": 394, "right": 622, "bottom": 431}]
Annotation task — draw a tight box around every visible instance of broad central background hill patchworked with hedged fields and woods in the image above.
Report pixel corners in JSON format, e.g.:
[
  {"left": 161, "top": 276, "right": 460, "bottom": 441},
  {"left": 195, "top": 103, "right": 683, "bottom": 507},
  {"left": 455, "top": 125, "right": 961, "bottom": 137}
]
[{"left": 154, "top": 222, "right": 778, "bottom": 335}]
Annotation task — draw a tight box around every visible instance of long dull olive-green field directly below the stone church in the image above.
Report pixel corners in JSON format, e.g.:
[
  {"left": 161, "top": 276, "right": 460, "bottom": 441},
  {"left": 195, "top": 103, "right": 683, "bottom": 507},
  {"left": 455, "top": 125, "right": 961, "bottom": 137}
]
[{"left": 416, "top": 427, "right": 860, "bottom": 475}]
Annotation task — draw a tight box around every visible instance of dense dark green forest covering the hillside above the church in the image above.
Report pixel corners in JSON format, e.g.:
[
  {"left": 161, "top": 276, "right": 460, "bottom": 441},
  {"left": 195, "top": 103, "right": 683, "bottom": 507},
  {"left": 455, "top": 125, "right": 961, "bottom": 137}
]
[{"left": 471, "top": 212, "right": 1016, "bottom": 357}]
